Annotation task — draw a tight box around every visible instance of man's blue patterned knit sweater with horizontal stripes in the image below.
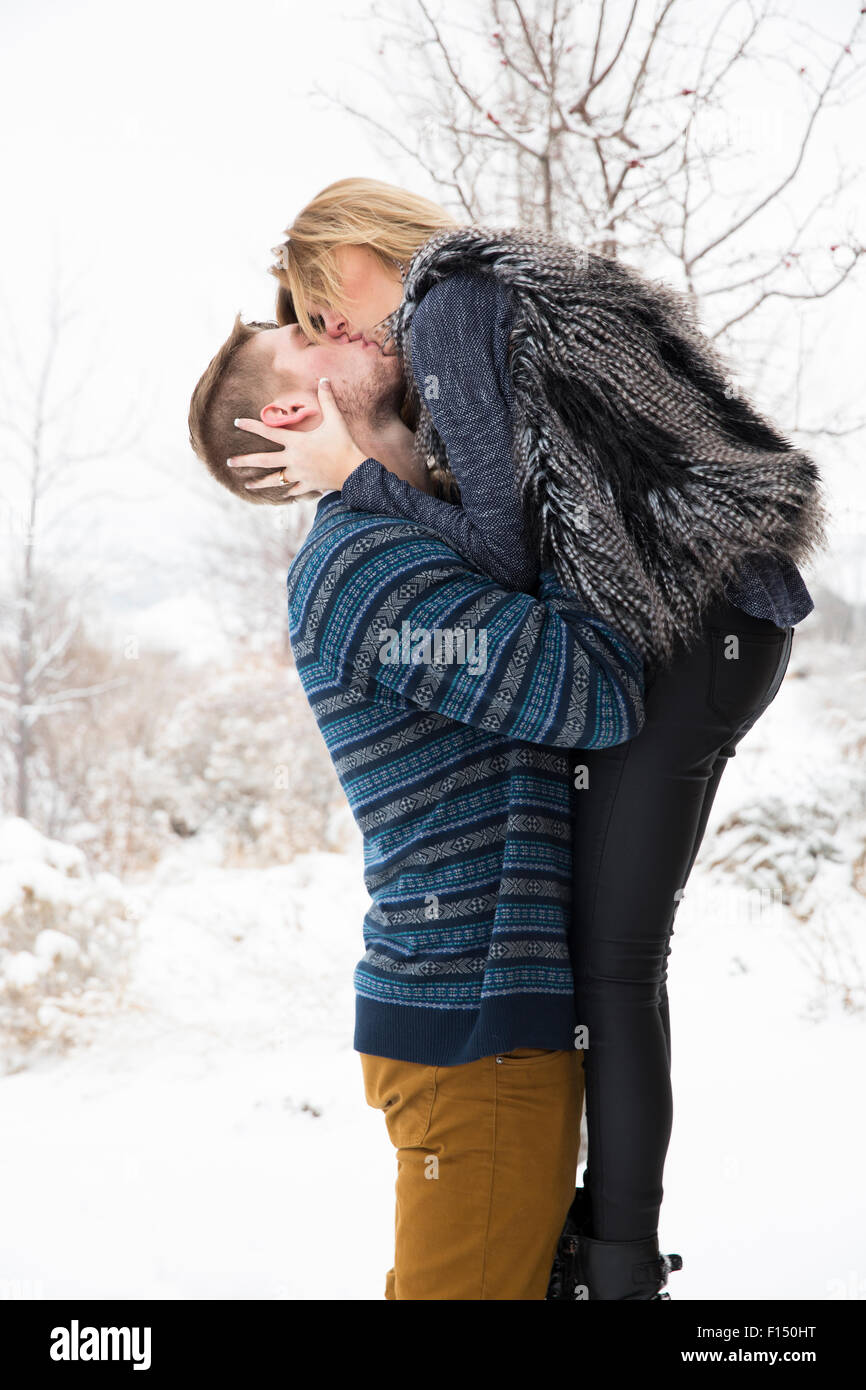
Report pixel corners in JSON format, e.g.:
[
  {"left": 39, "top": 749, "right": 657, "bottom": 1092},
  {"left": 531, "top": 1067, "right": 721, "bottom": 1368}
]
[{"left": 288, "top": 493, "right": 644, "bottom": 1066}]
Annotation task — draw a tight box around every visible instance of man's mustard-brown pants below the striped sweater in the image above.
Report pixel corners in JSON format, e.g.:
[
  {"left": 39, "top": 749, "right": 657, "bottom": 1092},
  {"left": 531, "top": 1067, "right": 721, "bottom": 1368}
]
[{"left": 360, "top": 1048, "right": 584, "bottom": 1300}]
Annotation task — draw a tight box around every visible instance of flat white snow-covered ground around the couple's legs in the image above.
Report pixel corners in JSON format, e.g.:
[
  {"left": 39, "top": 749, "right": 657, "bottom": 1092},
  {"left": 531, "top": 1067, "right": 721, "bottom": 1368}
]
[{"left": 0, "top": 650, "right": 866, "bottom": 1300}]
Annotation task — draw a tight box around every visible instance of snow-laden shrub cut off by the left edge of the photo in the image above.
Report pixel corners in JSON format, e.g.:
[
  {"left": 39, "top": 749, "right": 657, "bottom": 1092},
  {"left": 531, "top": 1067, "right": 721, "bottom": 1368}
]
[{"left": 0, "top": 816, "right": 135, "bottom": 1072}]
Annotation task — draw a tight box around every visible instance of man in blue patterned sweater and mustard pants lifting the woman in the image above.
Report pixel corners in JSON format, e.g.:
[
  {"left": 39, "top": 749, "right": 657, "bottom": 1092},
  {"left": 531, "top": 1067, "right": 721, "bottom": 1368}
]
[{"left": 190, "top": 320, "right": 644, "bottom": 1300}]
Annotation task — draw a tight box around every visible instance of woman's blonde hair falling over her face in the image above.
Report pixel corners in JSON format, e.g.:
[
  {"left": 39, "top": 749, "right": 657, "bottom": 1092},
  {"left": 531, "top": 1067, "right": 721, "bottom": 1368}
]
[{"left": 271, "top": 178, "right": 460, "bottom": 342}]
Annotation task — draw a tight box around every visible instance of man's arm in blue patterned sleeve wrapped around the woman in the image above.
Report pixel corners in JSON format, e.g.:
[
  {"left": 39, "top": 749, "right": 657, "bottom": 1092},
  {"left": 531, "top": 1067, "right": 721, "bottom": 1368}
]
[{"left": 289, "top": 517, "right": 644, "bottom": 748}]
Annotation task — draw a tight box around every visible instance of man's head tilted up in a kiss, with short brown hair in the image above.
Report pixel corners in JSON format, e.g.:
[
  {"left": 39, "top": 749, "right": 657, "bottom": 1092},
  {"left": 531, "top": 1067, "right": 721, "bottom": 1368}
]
[{"left": 189, "top": 314, "right": 403, "bottom": 503}]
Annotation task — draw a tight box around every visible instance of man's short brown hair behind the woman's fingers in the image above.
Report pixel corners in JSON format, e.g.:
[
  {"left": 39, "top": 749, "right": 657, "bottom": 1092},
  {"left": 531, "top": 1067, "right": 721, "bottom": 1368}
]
[{"left": 189, "top": 314, "right": 297, "bottom": 505}]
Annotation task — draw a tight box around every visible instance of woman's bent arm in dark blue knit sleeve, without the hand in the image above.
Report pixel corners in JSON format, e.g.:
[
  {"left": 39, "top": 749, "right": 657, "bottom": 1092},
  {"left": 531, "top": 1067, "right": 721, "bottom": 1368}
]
[{"left": 342, "top": 274, "right": 539, "bottom": 594}]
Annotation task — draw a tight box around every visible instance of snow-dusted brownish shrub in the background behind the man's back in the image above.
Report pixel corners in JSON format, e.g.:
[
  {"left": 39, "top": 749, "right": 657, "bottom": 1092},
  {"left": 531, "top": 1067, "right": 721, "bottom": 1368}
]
[{"left": 47, "top": 652, "right": 353, "bottom": 876}]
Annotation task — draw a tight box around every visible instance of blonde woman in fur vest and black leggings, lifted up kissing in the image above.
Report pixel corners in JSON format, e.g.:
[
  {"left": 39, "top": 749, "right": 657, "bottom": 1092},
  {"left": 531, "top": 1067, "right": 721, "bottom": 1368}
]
[{"left": 234, "top": 179, "right": 823, "bottom": 1300}]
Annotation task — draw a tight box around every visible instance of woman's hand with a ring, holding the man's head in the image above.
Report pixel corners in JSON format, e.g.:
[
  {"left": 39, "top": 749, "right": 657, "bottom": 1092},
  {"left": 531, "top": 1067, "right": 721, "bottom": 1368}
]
[{"left": 227, "top": 377, "right": 367, "bottom": 498}]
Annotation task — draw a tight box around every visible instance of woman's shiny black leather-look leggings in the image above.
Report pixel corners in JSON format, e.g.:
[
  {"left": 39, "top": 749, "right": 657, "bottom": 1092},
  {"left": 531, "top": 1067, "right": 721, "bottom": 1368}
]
[{"left": 570, "top": 602, "right": 792, "bottom": 1240}]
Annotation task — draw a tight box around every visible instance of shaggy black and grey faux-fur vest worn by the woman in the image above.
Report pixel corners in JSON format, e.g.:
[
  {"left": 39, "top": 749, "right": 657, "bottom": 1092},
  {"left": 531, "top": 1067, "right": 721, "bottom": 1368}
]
[{"left": 391, "top": 227, "right": 824, "bottom": 666}]
